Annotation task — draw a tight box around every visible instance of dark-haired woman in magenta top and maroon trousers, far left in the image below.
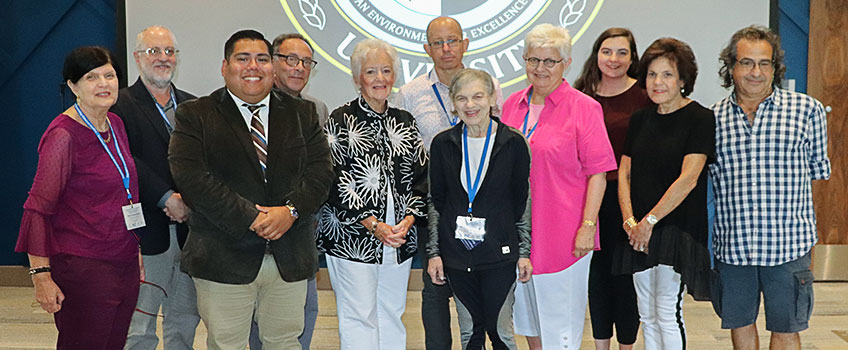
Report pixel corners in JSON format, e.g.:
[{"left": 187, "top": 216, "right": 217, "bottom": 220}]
[{"left": 15, "top": 46, "right": 143, "bottom": 349}]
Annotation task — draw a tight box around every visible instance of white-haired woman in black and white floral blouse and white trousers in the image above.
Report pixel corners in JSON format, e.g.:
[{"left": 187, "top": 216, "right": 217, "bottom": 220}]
[{"left": 318, "top": 39, "right": 427, "bottom": 349}]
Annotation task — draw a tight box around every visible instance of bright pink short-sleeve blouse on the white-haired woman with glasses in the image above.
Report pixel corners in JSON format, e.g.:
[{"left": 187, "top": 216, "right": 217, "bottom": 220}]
[{"left": 502, "top": 79, "right": 617, "bottom": 274}]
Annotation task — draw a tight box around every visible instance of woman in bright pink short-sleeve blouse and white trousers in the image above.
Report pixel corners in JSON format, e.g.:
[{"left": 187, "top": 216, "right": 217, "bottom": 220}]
[{"left": 503, "top": 24, "right": 616, "bottom": 349}]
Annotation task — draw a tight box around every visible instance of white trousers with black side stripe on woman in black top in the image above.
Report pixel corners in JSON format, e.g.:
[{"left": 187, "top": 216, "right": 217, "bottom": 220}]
[{"left": 633, "top": 265, "right": 686, "bottom": 350}]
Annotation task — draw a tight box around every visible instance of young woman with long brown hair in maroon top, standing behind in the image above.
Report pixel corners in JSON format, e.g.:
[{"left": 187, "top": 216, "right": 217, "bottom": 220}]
[{"left": 574, "top": 28, "right": 652, "bottom": 350}]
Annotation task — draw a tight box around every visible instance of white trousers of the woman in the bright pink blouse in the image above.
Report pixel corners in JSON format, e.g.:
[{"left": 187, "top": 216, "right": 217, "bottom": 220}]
[{"left": 513, "top": 252, "right": 592, "bottom": 350}]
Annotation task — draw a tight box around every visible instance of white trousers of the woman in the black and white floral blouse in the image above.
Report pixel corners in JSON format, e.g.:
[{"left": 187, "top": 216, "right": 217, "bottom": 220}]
[{"left": 327, "top": 245, "right": 412, "bottom": 350}]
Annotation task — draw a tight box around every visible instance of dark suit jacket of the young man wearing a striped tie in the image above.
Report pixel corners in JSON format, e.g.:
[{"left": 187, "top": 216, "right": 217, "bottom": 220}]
[{"left": 169, "top": 88, "right": 333, "bottom": 284}]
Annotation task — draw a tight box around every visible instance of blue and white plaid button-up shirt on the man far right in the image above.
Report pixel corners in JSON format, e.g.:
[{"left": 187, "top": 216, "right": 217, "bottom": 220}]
[{"left": 710, "top": 88, "right": 830, "bottom": 266}]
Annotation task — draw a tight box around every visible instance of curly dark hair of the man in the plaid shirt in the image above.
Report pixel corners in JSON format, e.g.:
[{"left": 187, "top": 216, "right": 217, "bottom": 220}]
[{"left": 718, "top": 25, "right": 786, "bottom": 88}]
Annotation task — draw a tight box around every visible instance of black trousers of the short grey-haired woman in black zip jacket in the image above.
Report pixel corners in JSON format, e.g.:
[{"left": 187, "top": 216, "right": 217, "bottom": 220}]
[{"left": 445, "top": 264, "right": 515, "bottom": 350}]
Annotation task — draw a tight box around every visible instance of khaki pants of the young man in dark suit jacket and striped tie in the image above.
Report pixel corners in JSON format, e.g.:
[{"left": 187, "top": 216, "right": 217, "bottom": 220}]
[{"left": 194, "top": 254, "right": 306, "bottom": 350}]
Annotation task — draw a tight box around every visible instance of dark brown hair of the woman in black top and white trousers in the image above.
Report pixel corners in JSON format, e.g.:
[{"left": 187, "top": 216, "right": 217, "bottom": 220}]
[{"left": 639, "top": 38, "right": 698, "bottom": 97}]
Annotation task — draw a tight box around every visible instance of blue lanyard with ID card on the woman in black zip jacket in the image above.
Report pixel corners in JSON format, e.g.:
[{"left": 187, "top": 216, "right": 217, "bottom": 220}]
[{"left": 454, "top": 119, "right": 492, "bottom": 243}]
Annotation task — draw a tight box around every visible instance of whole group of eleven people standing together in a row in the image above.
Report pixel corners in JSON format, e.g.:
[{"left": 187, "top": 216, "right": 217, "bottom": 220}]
[{"left": 16, "top": 17, "right": 830, "bottom": 349}]
